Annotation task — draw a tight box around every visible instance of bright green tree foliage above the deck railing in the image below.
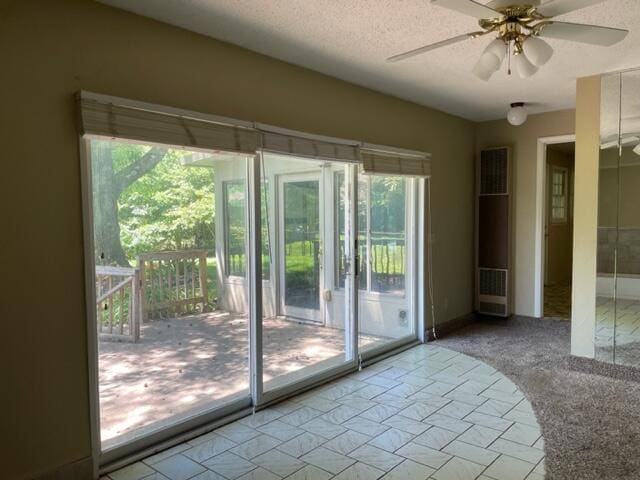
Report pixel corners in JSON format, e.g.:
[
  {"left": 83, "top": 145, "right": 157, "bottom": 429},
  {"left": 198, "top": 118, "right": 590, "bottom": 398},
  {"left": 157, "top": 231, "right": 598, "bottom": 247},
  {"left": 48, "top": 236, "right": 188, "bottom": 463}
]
[{"left": 93, "top": 141, "right": 214, "bottom": 264}]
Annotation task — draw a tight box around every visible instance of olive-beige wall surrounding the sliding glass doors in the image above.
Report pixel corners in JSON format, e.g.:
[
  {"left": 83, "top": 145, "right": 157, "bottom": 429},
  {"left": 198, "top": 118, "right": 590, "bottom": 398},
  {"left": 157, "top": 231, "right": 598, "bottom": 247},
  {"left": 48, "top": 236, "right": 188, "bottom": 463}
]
[{"left": 0, "top": 0, "right": 478, "bottom": 479}]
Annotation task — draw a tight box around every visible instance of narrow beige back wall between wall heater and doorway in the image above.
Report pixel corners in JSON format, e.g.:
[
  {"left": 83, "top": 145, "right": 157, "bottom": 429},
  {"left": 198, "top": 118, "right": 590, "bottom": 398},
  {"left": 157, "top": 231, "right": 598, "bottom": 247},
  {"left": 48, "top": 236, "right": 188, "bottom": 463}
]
[{"left": 476, "top": 110, "right": 575, "bottom": 316}]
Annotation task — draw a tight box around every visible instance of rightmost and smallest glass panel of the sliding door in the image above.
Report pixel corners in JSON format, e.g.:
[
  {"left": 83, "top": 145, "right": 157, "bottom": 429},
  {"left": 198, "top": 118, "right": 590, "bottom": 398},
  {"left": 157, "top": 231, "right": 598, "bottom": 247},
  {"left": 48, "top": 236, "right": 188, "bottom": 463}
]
[{"left": 358, "top": 175, "right": 417, "bottom": 352}]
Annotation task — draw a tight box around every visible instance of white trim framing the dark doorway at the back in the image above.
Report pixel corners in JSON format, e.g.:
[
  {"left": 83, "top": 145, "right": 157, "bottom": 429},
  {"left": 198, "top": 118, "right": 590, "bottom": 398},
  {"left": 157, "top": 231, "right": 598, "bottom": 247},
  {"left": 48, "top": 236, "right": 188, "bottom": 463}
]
[{"left": 533, "top": 133, "right": 576, "bottom": 318}]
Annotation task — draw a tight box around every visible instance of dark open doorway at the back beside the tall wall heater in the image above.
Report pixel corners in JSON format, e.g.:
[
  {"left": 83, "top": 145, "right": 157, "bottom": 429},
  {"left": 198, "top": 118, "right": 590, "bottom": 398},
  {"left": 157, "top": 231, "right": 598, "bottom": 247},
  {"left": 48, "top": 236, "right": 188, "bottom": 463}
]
[{"left": 543, "top": 142, "right": 575, "bottom": 320}]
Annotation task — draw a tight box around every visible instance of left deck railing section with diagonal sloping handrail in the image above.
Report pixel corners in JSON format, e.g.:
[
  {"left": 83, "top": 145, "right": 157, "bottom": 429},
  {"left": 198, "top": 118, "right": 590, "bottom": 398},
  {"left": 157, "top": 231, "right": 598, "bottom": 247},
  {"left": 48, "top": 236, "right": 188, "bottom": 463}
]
[{"left": 96, "top": 266, "right": 140, "bottom": 342}]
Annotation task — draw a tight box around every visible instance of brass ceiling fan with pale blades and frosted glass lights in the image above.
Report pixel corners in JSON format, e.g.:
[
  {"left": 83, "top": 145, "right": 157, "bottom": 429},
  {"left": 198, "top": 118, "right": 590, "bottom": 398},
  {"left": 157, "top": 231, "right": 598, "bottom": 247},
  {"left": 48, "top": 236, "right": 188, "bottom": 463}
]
[{"left": 387, "top": 0, "right": 629, "bottom": 81}]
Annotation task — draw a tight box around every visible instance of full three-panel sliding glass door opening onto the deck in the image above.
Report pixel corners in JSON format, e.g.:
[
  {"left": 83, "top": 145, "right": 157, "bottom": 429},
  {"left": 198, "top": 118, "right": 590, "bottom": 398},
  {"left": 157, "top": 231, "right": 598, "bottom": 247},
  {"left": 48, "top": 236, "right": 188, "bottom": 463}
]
[{"left": 81, "top": 92, "right": 423, "bottom": 463}]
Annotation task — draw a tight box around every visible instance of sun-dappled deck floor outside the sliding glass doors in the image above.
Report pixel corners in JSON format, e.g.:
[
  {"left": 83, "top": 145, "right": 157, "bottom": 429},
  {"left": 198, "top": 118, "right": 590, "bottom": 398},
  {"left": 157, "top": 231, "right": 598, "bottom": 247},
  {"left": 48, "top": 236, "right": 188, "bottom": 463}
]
[{"left": 99, "top": 311, "right": 384, "bottom": 447}]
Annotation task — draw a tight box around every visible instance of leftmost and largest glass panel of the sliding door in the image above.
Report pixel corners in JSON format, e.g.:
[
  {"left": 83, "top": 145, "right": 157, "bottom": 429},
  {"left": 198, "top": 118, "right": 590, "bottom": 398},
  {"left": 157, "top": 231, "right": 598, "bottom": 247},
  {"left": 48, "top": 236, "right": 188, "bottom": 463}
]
[{"left": 87, "top": 138, "right": 249, "bottom": 452}]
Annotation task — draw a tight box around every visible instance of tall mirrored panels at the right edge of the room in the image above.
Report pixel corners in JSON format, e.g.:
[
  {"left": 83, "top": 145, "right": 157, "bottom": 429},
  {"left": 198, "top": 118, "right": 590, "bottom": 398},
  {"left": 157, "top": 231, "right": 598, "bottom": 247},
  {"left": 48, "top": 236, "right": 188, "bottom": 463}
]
[{"left": 595, "top": 71, "right": 640, "bottom": 366}]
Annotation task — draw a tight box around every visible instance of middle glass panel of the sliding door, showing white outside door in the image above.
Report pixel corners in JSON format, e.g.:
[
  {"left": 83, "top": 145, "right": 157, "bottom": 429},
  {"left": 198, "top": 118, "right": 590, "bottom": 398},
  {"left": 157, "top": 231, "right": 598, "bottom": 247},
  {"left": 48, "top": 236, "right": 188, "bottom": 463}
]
[{"left": 259, "top": 154, "right": 355, "bottom": 392}]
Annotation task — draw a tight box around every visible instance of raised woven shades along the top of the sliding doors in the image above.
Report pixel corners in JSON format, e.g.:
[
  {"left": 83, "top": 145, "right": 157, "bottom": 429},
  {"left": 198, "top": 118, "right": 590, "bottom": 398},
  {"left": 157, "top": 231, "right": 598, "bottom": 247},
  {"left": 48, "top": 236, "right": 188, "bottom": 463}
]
[{"left": 77, "top": 92, "right": 431, "bottom": 177}]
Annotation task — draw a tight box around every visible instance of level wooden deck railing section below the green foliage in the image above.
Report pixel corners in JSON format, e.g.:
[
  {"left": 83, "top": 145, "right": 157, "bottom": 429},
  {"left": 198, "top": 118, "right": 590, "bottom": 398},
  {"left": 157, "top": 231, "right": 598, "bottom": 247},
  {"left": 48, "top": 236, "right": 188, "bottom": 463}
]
[{"left": 138, "top": 250, "right": 209, "bottom": 320}]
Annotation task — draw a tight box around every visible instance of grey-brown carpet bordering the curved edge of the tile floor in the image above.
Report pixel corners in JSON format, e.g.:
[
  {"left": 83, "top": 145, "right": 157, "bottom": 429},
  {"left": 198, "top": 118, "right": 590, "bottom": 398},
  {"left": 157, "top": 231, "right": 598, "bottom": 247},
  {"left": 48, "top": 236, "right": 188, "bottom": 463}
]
[{"left": 436, "top": 318, "right": 640, "bottom": 480}]
